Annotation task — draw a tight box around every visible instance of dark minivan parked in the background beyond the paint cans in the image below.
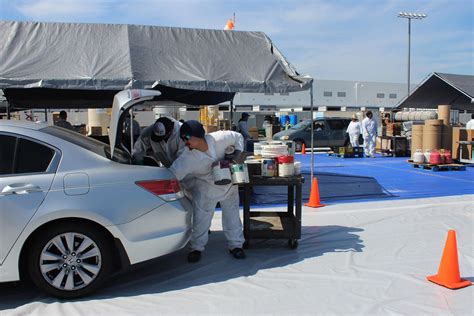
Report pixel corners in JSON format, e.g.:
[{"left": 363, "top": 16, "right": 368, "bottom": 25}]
[{"left": 273, "top": 117, "right": 362, "bottom": 151}]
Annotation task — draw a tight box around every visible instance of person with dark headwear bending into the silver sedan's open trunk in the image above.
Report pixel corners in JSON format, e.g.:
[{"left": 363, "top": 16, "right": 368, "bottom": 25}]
[{"left": 132, "top": 117, "right": 186, "bottom": 168}]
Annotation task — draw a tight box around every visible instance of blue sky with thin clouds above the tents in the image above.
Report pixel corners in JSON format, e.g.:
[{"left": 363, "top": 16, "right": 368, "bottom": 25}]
[{"left": 0, "top": 0, "right": 474, "bottom": 84}]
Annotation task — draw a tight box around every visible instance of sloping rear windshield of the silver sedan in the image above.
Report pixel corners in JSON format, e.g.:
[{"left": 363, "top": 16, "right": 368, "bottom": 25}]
[{"left": 41, "top": 126, "right": 128, "bottom": 163}]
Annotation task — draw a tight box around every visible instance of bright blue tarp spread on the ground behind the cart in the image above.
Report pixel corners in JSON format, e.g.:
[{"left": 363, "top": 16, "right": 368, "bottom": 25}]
[{"left": 251, "top": 154, "right": 474, "bottom": 206}]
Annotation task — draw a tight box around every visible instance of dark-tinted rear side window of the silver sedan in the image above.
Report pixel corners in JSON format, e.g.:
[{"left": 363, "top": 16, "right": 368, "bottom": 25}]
[{"left": 14, "top": 138, "right": 54, "bottom": 174}]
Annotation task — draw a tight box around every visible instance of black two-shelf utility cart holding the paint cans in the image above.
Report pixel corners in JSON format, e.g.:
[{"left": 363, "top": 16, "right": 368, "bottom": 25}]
[{"left": 241, "top": 175, "right": 304, "bottom": 249}]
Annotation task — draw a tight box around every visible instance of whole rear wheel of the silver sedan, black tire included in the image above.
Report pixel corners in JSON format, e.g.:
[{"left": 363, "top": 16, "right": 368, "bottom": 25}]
[{"left": 27, "top": 222, "right": 113, "bottom": 299}]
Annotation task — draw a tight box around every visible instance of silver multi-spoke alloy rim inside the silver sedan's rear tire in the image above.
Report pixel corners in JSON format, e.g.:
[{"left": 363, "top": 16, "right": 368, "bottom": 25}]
[{"left": 39, "top": 232, "right": 102, "bottom": 291}]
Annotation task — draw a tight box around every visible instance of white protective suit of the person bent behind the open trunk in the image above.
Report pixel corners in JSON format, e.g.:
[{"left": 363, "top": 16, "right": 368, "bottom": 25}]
[{"left": 132, "top": 118, "right": 186, "bottom": 168}]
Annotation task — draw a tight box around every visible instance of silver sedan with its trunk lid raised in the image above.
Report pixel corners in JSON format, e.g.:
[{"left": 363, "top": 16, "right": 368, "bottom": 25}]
[{"left": 0, "top": 92, "right": 191, "bottom": 299}]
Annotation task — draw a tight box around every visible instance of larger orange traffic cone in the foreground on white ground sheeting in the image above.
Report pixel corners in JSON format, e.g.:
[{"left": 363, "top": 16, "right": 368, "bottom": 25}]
[{"left": 426, "top": 230, "right": 471, "bottom": 290}]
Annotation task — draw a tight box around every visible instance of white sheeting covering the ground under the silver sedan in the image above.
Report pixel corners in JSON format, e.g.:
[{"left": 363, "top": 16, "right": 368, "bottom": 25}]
[{"left": 0, "top": 195, "right": 474, "bottom": 316}]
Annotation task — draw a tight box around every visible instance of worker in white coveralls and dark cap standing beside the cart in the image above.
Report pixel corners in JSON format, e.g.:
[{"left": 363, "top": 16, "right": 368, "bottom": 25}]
[{"left": 169, "top": 120, "right": 245, "bottom": 262}]
